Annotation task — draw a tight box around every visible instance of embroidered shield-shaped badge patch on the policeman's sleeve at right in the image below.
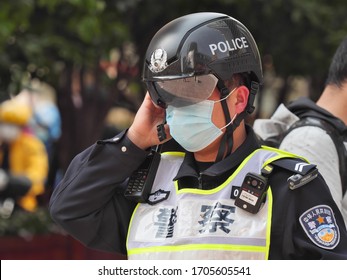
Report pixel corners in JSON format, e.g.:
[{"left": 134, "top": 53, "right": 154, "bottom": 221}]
[{"left": 299, "top": 205, "right": 340, "bottom": 250}]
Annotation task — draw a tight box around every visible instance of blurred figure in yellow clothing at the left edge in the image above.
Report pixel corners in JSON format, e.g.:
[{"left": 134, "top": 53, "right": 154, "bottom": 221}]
[{"left": 0, "top": 99, "right": 48, "bottom": 217}]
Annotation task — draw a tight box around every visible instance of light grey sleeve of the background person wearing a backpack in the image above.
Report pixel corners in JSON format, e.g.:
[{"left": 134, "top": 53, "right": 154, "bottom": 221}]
[{"left": 280, "top": 126, "right": 342, "bottom": 209}]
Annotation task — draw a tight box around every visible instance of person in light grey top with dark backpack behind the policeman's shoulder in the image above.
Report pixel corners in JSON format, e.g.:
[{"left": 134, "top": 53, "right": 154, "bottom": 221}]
[{"left": 253, "top": 37, "right": 347, "bottom": 225}]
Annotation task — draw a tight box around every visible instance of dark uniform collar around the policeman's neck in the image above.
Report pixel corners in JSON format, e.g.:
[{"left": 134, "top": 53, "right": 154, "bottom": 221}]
[{"left": 174, "top": 125, "right": 260, "bottom": 180}]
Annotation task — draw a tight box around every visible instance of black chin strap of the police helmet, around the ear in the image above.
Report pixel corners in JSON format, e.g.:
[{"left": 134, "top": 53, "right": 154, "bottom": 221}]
[{"left": 215, "top": 80, "right": 259, "bottom": 162}]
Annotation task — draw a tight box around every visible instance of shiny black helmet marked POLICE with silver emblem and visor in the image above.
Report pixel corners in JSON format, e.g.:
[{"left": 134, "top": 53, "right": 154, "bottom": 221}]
[{"left": 143, "top": 12, "right": 263, "bottom": 107}]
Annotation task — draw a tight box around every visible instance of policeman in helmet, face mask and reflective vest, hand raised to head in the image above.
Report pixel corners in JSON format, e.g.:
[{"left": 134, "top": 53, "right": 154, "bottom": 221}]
[{"left": 50, "top": 13, "right": 347, "bottom": 259}]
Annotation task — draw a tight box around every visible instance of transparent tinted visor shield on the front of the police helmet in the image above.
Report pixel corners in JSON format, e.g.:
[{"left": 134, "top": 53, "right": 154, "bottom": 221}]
[{"left": 146, "top": 74, "right": 218, "bottom": 108}]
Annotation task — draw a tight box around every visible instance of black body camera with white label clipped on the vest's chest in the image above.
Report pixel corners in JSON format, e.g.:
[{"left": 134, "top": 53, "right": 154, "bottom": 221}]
[{"left": 235, "top": 172, "right": 268, "bottom": 214}]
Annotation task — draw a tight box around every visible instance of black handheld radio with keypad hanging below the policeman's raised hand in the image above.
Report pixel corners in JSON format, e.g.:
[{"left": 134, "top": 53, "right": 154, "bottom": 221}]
[{"left": 124, "top": 145, "right": 161, "bottom": 203}]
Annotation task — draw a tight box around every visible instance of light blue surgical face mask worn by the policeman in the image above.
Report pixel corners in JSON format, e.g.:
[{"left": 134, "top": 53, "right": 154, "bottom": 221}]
[{"left": 166, "top": 89, "right": 236, "bottom": 152}]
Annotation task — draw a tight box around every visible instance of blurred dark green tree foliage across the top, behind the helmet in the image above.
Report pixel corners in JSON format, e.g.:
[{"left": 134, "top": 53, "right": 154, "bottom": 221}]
[{"left": 0, "top": 0, "right": 347, "bottom": 98}]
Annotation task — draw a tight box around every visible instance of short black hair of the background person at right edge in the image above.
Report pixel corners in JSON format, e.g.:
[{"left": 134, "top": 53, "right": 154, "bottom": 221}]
[{"left": 325, "top": 37, "right": 347, "bottom": 87}]
